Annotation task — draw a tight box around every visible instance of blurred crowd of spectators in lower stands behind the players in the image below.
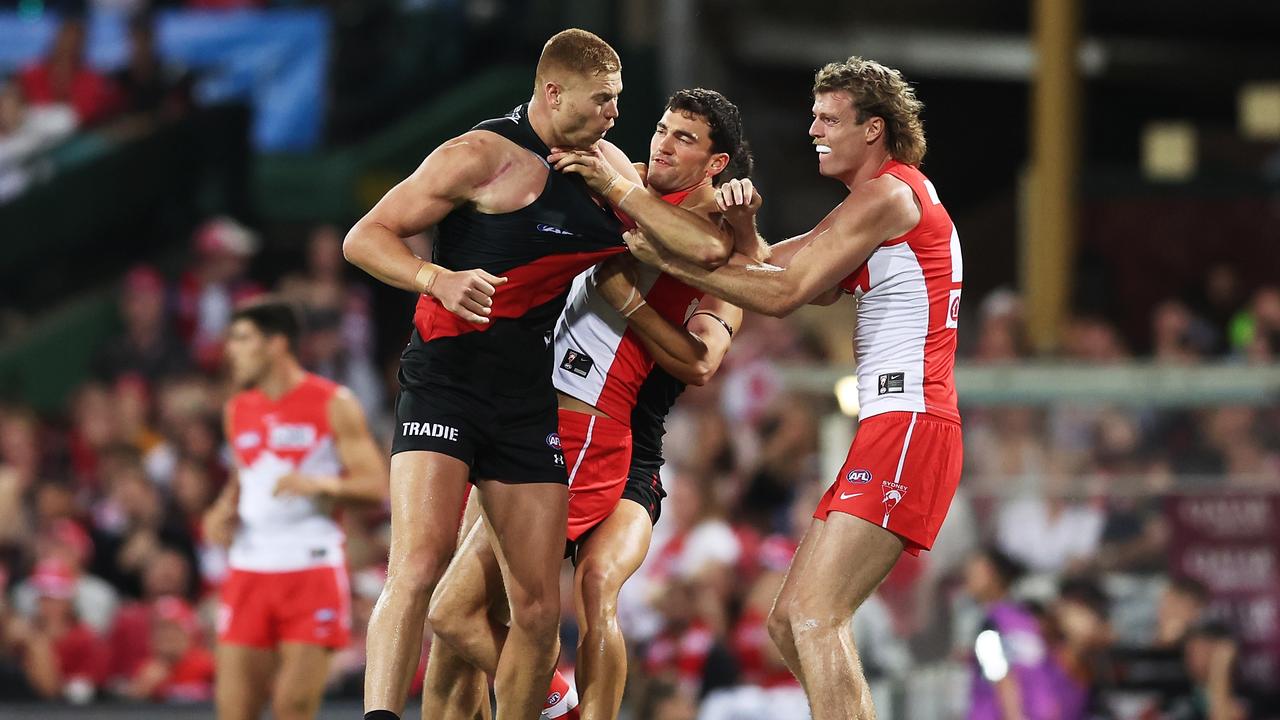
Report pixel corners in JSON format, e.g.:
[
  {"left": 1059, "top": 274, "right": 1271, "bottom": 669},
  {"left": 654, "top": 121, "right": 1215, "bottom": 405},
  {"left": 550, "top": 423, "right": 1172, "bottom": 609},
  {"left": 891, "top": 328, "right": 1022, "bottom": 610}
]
[{"left": 0, "top": 218, "right": 1280, "bottom": 720}]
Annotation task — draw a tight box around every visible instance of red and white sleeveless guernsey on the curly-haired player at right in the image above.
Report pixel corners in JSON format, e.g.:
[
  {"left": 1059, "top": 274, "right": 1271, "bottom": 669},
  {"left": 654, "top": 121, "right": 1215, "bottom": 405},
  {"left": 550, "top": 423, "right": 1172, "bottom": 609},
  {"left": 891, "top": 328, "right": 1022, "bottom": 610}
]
[{"left": 840, "top": 160, "right": 964, "bottom": 423}]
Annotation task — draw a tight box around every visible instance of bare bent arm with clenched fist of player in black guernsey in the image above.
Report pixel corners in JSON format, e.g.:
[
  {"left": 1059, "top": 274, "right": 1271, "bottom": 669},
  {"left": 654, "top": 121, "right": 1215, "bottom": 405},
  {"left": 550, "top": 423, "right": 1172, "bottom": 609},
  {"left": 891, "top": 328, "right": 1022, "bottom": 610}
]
[{"left": 342, "top": 131, "right": 507, "bottom": 323}]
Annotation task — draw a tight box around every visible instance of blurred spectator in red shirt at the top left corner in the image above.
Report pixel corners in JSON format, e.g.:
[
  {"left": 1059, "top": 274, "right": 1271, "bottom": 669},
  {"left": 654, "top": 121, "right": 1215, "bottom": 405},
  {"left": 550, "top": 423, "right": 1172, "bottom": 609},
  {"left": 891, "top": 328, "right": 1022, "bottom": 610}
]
[{"left": 19, "top": 18, "right": 119, "bottom": 126}]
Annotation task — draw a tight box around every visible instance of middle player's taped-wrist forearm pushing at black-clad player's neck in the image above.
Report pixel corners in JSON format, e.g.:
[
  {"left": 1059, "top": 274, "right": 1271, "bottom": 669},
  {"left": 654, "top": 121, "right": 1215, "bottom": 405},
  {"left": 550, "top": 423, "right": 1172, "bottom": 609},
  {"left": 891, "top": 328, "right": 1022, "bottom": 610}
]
[{"left": 547, "top": 141, "right": 733, "bottom": 269}]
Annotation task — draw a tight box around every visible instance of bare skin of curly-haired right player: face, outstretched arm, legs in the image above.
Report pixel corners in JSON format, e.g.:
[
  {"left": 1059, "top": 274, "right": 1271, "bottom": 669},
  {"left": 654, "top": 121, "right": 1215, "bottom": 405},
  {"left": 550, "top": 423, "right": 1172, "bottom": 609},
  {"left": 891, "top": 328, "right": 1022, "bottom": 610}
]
[{"left": 614, "top": 91, "right": 922, "bottom": 720}]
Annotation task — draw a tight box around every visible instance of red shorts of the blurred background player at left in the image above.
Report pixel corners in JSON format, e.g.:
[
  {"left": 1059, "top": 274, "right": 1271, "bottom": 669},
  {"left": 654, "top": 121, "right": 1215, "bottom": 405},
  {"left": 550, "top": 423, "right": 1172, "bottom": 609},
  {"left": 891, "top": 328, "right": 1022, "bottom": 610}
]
[{"left": 218, "top": 568, "right": 351, "bottom": 650}]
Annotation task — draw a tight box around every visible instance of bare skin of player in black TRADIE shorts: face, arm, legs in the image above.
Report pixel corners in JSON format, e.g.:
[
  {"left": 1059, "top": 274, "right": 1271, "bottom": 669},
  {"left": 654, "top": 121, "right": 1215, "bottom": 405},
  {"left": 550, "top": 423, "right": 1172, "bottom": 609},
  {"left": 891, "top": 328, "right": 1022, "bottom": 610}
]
[{"left": 343, "top": 57, "right": 636, "bottom": 720}]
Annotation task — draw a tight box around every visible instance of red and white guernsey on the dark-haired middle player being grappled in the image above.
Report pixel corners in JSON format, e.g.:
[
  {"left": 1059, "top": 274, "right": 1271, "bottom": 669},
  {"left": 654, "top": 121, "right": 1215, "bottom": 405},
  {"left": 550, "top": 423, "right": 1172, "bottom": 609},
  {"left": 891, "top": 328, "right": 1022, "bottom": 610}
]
[{"left": 554, "top": 191, "right": 703, "bottom": 427}]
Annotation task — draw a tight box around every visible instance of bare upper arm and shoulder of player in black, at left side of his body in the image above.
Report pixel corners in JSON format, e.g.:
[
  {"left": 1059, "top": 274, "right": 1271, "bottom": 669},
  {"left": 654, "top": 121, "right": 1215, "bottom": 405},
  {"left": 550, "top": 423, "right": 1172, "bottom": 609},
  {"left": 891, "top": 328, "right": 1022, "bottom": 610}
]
[{"left": 364, "top": 131, "right": 498, "bottom": 237}]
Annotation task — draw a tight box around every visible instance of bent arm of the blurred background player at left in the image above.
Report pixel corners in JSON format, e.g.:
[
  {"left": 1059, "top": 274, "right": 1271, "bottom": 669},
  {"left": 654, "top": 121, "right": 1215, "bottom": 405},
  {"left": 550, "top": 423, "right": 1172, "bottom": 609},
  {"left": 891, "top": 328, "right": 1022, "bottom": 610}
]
[{"left": 275, "top": 388, "right": 390, "bottom": 502}]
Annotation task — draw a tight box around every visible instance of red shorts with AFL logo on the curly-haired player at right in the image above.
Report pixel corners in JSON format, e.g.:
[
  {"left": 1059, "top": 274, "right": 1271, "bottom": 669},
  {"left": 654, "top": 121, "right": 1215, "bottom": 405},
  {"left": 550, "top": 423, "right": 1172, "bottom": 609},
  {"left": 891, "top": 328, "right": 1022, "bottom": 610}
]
[{"left": 813, "top": 413, "right": 964, "bottom": 555}]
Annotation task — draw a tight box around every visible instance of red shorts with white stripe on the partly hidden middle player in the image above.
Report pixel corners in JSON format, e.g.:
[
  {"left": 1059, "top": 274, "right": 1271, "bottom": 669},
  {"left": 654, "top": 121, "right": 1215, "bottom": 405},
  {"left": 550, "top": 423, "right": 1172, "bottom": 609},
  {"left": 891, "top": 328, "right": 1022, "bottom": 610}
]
[{"left": 559, "top": 409, "right": 631, "bottom": 541}]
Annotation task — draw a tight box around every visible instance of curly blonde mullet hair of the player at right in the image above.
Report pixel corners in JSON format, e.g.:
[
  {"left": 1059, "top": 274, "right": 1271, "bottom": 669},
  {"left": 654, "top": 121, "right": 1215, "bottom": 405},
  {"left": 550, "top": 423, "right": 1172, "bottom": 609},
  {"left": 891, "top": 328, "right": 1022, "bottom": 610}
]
[{"left": 813, "top": 55, "right": 925, "bottom": 165}]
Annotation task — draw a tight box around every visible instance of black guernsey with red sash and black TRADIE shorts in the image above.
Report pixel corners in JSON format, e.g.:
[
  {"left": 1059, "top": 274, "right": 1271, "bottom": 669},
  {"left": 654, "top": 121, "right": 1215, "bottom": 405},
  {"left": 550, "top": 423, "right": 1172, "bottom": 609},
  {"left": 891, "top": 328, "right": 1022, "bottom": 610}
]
[{"left": 392, "top": 106, "right": 626, "bottom": 483}]
